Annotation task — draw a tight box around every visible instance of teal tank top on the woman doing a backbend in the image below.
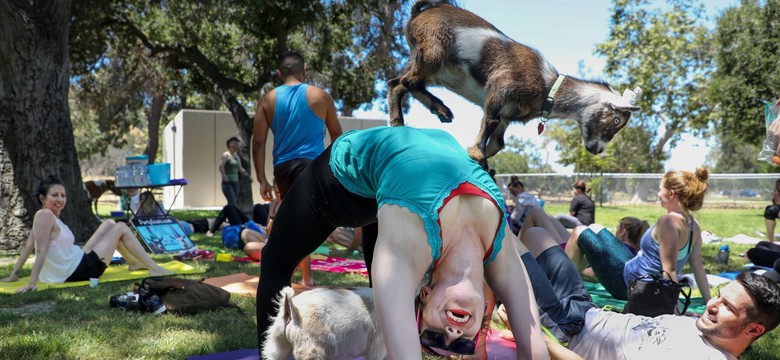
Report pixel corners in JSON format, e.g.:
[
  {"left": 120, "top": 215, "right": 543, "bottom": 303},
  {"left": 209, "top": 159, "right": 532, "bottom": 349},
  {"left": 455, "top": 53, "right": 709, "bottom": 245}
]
[{"left": 330, "top": 126, "right": 507, "bottom": 264}]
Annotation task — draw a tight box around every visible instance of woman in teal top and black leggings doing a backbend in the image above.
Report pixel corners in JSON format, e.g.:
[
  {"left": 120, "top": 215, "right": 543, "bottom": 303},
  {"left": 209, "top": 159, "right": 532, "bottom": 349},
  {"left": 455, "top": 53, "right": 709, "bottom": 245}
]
[{"left": 257, "top": 127, "right": 547, "bottom": 359}]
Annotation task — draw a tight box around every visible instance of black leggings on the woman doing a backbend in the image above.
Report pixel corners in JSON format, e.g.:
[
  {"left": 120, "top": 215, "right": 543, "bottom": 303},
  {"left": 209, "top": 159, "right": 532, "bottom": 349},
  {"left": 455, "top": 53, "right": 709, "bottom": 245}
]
[{"left": 257, "top": 147, "right": 378, "bottom": 353}]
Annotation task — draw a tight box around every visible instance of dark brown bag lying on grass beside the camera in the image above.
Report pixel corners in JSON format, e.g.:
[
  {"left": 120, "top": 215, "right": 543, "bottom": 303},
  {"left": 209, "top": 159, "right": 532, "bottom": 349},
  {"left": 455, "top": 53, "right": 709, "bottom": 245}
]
[{"left": 135, "top": 277, "right": 238, "bottom": 315}]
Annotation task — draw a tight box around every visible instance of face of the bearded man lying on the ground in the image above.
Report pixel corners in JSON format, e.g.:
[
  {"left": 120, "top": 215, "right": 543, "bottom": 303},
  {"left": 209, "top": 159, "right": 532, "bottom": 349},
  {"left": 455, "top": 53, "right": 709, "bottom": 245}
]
[{"left": 696, "top": 281, "right": 753, "bottom": 339}]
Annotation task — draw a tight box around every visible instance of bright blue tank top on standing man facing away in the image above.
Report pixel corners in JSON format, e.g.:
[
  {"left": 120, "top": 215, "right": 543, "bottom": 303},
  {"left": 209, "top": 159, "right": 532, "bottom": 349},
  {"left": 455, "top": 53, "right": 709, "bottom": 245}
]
[{"left": 271, "top": 84, "right": 325, "bottom": 166}]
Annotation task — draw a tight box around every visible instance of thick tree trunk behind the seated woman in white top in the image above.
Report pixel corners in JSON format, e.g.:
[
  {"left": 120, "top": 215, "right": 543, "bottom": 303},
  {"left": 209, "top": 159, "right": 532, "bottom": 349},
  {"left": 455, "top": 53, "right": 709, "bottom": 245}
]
[{"left": 0, "top": 0, "right": 98, "bottom": 251}]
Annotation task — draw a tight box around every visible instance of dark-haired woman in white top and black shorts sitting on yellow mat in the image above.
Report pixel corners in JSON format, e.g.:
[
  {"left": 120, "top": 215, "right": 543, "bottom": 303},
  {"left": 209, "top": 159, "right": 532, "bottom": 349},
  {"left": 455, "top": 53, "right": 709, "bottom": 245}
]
[{"left": 2, "top": 176, "right": 172, "bottom": 293}]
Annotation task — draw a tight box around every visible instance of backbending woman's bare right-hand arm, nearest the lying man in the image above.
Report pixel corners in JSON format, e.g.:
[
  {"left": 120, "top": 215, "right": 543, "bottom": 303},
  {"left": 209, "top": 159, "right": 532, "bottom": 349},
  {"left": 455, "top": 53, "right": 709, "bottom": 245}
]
[{"left": 485, "top": 227, "right": 550, "bottom": 359}]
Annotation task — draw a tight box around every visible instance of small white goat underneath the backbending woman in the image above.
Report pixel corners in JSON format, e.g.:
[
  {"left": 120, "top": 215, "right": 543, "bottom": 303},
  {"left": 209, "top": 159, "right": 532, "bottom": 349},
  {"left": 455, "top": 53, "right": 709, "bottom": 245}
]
[{"left": 262, "top": 287, "right": 387, "bottom": 360}]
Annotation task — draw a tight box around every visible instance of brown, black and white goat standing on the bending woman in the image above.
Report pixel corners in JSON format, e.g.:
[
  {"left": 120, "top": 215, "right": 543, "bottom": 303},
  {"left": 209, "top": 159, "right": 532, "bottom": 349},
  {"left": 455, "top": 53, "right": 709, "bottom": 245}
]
[{"left": 388, "top": 0, "right": 641, "bottom": 168}]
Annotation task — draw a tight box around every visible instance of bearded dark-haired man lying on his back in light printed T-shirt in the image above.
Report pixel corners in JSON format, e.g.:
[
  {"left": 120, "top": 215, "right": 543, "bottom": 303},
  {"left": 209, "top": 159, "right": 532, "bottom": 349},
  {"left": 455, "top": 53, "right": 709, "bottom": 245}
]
[{"left": 522, "top": 228, "right": 780, "bottom": 360}]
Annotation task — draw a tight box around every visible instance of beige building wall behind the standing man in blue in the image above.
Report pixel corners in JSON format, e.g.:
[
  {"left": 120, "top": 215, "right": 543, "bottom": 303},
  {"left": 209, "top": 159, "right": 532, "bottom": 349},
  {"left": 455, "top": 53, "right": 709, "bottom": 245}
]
[{"left": 162, "top": 110, "right": 387, "bottom": 209}]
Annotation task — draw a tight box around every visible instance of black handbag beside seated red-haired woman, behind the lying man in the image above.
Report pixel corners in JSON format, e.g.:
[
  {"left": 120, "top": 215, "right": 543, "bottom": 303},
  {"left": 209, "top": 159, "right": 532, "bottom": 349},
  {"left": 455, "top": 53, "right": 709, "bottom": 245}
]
[{"left": 623, "top": 271, "right": 691, "bottom": 317}]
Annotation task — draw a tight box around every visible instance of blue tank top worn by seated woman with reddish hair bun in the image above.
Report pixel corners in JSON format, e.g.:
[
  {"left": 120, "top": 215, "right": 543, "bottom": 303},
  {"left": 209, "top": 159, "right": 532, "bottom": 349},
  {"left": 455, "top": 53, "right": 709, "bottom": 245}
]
[{"left": 623, "top": 218, "right": 693, "bottom": 285}]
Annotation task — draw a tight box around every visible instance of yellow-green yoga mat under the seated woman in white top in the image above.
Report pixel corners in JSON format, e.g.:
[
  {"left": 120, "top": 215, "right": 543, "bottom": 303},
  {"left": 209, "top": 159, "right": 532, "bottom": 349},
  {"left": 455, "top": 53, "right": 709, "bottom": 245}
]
[{"left": 0, "top": 260, "right": 206, "bottom": 293}]
